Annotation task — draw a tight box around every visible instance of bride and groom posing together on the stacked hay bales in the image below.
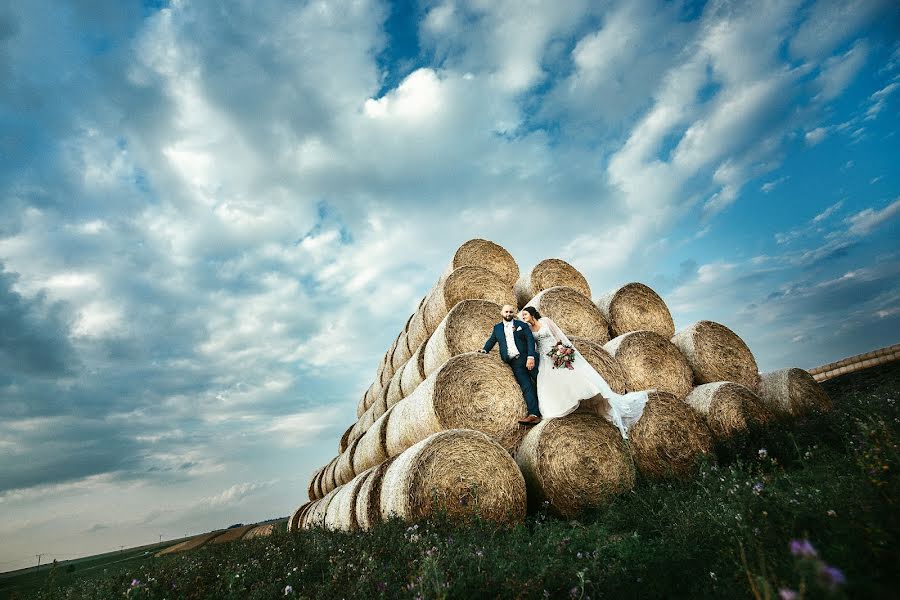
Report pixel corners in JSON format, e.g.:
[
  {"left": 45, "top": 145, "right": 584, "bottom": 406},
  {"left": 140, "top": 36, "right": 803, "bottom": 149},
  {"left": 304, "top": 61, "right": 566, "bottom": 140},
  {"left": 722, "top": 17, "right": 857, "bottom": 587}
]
[{"left": 479, "top": 304, "right": 647, "bottom": 439}]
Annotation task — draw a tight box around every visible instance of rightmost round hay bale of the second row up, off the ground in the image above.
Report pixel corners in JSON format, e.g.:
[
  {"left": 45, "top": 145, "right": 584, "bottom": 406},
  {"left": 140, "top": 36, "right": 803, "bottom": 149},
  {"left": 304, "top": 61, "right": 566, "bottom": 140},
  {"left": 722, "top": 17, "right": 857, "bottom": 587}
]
[{"left": 672, "top": 321, "right": 759, "bottom": 391}]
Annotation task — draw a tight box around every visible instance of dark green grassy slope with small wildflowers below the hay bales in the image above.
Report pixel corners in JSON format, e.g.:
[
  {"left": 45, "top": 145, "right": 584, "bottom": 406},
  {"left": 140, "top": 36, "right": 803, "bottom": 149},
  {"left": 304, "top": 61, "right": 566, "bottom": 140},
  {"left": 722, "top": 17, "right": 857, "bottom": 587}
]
[{"left": 8, "top": 363, "right": 900, "bottom": 599}]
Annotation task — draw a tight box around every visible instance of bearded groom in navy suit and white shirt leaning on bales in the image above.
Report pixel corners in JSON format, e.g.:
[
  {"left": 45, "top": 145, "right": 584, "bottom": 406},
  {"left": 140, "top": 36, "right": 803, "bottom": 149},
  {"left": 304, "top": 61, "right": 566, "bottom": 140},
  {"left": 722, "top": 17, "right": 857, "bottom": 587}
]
[{"left": 479, "top": 304, "right": 541, "bottom": 425}]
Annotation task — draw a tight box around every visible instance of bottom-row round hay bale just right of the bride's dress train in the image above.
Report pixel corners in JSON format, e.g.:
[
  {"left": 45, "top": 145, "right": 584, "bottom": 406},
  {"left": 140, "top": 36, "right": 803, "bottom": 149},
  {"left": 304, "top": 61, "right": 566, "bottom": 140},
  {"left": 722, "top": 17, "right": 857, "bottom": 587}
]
[{"left": 626, "top": 392, "right": 713, "bottom": 479}]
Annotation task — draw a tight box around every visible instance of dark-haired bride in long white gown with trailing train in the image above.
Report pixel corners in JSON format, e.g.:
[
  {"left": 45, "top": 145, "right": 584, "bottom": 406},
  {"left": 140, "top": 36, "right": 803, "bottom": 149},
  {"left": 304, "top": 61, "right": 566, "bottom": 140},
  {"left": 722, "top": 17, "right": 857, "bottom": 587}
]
[{"left": 520, "top": 306, "right": 647, "bottom": 439}]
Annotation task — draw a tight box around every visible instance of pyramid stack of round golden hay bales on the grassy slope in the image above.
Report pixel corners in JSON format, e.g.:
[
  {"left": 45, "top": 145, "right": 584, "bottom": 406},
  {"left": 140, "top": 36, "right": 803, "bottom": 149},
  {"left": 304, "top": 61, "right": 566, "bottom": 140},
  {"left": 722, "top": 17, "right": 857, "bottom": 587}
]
[{"left": 288, "top": 240, "right": 828, "bottom": 530}]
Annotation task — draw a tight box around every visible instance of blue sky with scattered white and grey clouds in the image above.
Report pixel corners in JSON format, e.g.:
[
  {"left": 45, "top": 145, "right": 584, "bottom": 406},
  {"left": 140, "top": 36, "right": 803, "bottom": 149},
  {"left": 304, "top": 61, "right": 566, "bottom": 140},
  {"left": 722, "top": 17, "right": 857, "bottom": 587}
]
[{"left": 0, "top": 0, "right": 900, "bottom": 571}]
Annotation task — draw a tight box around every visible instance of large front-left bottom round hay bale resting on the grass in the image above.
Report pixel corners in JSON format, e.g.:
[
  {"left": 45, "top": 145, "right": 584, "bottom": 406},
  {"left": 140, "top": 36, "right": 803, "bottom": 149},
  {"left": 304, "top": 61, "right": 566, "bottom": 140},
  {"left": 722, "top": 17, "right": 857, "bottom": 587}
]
[{"left": 381, "top": 429, "right": 526, "bottom": 522}]
